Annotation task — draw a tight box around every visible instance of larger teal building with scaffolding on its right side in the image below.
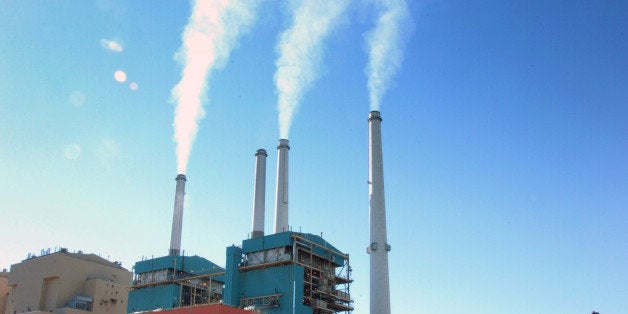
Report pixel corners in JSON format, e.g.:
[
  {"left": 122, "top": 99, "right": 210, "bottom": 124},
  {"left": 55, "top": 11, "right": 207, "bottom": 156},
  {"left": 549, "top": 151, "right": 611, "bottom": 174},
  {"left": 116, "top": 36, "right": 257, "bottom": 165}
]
[{"left": 224, "top": 232, "right": 353, "bottom": 313}]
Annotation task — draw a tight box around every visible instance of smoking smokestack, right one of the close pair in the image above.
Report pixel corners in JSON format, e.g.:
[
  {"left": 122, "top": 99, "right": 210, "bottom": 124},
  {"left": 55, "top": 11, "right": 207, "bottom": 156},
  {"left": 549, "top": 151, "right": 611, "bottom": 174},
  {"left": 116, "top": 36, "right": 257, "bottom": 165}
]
[{"left": 275, "top": 139, "right": 290, "bottom": 233}]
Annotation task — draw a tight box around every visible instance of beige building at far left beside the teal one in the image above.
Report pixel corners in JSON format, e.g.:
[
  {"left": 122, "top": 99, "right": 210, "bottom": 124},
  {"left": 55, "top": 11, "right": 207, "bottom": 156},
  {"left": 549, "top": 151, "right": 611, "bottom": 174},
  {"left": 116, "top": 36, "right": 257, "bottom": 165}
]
[{"left": 4, "top": 249, "right": 132, "bottom": 314}]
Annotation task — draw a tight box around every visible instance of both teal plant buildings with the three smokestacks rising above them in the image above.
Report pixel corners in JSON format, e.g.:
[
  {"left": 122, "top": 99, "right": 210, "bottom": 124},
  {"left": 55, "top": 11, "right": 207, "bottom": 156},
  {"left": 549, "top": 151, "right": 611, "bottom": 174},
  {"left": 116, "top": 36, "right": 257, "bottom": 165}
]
[{"left": 128, "top": 139, "right": 353, "bottom": 313}]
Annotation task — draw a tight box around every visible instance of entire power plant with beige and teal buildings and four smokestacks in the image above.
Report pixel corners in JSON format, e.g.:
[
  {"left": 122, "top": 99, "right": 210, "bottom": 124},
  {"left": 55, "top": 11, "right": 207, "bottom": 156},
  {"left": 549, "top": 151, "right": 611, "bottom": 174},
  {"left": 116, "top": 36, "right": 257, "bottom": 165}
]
[{"left": 0, "top": 111, "right": 390, "bottom": 314}]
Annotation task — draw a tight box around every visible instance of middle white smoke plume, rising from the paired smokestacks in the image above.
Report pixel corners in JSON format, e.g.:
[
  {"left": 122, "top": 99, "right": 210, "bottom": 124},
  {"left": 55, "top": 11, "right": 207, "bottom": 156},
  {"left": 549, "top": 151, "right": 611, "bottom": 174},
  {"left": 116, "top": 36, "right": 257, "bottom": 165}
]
[{"left": 275, "top": 0, "right": 348, "bottom": 138}]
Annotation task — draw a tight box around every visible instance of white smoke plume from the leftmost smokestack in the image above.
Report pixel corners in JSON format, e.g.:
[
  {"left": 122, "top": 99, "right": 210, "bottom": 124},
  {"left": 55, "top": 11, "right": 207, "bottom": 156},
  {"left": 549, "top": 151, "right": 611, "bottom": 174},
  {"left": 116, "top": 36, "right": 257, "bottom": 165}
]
[{"left": 172, "top": 0, "right": 256, "bottom": 174}]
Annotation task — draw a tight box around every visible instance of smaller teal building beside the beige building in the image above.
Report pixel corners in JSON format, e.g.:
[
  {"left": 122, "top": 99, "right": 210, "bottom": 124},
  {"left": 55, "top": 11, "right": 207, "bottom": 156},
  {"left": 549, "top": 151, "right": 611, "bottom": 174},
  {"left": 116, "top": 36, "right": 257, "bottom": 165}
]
[{"left": 127, "top": 255, "right": 225, "bottom": 313}]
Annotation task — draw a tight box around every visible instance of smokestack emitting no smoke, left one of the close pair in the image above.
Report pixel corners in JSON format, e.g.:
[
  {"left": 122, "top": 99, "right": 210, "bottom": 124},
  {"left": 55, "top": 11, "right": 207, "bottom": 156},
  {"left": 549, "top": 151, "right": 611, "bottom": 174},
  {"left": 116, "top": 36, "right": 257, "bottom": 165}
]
[{"left": 251, "top": 149, "right": 268, "bottom": 238}]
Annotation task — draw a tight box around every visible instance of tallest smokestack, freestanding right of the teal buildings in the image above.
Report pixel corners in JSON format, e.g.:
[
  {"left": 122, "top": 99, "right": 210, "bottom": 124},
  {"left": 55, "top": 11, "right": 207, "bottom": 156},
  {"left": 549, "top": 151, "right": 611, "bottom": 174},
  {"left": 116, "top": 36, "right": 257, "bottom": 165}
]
[{"left": 367, "top": 111, "right": 390, "bottom": 314}]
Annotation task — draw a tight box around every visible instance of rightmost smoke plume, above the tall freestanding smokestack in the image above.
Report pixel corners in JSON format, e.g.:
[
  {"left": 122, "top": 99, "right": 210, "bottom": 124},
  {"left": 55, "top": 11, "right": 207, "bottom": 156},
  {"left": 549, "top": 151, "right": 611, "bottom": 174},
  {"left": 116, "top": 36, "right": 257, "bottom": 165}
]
[{"left": 366, "top": 0, "right": 410, "bottom": 110}]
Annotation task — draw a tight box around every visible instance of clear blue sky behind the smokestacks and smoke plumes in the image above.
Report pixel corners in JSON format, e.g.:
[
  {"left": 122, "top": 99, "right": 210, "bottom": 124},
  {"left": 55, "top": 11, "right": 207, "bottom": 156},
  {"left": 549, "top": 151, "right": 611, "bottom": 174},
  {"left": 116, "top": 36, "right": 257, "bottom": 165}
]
[{"left": 0, "top": 0, "right": 628, "bottom": 314}]
